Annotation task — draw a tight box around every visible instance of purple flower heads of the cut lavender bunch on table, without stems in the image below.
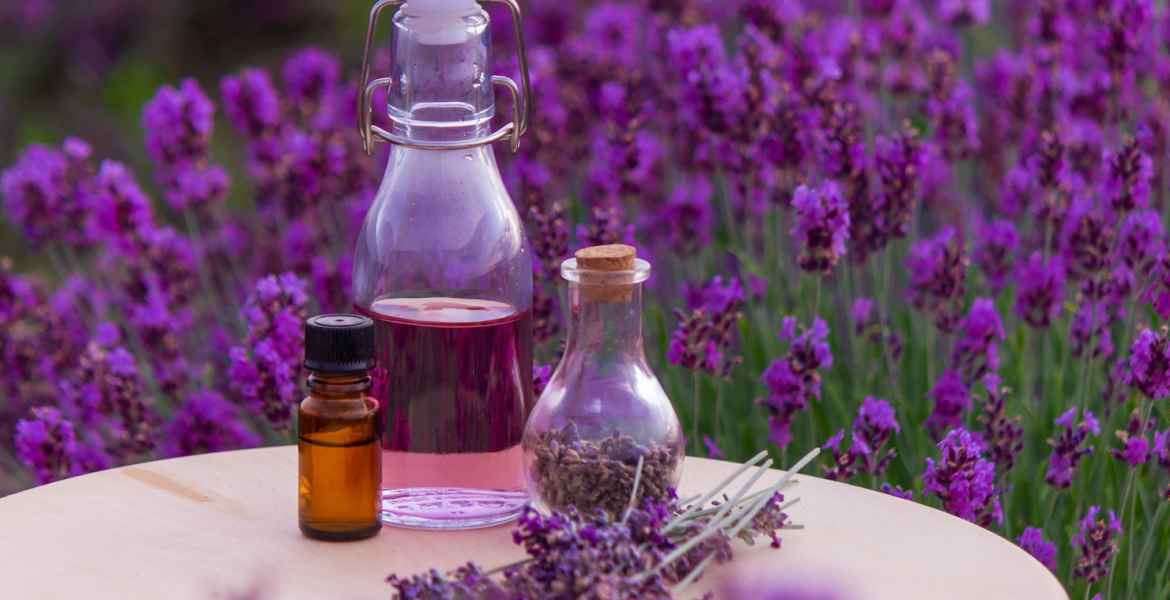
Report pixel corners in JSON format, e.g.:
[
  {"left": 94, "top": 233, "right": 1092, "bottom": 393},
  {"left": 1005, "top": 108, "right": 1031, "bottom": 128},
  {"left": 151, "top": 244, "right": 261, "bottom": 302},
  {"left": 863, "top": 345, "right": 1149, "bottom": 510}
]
[{"left": 386, "top": 494, "right": 787, "bottom": 600}]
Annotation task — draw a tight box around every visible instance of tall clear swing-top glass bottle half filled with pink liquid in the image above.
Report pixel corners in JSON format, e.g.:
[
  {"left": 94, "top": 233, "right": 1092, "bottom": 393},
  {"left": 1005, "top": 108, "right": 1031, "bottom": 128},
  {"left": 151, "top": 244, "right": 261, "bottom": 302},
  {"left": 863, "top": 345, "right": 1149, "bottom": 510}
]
[{"left": 353, "top": 0, "right": 535, "bottom": 529}]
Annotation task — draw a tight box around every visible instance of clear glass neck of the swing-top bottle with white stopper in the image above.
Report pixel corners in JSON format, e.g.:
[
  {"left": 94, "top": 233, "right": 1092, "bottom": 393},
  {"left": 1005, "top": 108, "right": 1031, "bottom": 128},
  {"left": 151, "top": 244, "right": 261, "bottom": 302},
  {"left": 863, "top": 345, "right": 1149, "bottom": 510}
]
[{"left": 387, "top": 5, "right": 495, "bottom": 142}]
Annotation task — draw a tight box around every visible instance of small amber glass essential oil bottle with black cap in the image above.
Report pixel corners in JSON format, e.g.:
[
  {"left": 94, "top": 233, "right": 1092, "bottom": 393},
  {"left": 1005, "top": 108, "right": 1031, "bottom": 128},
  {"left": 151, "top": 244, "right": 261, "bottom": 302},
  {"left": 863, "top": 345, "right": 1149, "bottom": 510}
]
[{"left": 297, "top": 315, "right": 381, "bottom": 540}]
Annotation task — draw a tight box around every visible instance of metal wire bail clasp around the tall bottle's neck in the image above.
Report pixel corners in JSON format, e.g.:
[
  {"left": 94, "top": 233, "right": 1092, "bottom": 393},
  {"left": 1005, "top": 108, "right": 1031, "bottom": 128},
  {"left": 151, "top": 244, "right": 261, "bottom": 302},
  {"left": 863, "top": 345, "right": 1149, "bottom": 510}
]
[{"left": 358, "top": 0, "right": 532, "bottom": 153}]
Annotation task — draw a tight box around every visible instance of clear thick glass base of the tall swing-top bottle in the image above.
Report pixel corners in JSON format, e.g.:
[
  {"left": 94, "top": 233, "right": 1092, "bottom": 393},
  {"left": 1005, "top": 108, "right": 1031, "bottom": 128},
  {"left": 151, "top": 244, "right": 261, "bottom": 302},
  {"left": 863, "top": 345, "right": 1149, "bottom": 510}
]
[{"left": 381, "top": 488, "right": 529, "bottom": 530}]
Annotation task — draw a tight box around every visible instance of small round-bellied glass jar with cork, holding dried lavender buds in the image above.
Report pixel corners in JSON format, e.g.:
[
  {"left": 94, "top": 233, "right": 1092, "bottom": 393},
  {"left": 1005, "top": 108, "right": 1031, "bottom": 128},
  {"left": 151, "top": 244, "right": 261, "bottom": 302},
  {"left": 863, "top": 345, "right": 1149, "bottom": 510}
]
[{"left": 523, "top": 244, "right": 684, "bottom": 515}]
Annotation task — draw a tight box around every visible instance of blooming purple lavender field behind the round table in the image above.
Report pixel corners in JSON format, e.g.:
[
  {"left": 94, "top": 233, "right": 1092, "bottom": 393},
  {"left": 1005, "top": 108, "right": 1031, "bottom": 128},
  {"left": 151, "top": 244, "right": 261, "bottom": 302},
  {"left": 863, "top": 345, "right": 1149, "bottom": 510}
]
[{"left": 0, "top": 0, "right": 1170, "bottom": 599}]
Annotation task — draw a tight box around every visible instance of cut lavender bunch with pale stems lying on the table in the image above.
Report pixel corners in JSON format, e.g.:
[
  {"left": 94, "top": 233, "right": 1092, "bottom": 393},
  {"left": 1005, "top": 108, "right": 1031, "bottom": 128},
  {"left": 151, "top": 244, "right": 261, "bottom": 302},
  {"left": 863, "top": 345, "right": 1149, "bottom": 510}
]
[{"left": 386, "top": 449, "right": 818, "bottom": 600}]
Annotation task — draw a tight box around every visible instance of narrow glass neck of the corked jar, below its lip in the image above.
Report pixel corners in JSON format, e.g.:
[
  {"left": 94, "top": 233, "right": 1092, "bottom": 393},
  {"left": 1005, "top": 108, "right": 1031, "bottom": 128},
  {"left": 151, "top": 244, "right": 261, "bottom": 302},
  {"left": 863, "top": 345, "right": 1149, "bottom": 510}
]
[{"left": 565, "top": 282, "right": 646, "bottom": 361}]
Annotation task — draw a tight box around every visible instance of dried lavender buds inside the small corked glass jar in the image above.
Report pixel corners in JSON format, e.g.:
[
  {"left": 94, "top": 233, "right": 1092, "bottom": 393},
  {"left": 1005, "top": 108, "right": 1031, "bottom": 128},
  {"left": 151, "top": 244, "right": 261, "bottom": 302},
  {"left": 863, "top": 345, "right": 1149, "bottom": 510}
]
[{"left": 525, "top": 421, "right": 682, "bottom": 516}]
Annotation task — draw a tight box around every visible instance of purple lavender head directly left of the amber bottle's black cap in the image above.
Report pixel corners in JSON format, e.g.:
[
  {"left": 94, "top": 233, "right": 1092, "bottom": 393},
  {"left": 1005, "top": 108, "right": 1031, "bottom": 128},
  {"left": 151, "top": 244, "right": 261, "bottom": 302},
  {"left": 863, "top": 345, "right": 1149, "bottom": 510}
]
[{"left": 228, "top": 273, "right": 309, "bottom": 428}]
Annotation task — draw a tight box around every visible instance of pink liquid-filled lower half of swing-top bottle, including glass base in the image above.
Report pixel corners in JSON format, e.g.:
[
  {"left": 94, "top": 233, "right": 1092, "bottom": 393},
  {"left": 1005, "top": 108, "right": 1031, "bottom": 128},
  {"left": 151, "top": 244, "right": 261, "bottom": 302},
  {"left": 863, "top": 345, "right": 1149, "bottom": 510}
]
[{"left": 362, "top": 297, "right": 535, "bottom": 529}]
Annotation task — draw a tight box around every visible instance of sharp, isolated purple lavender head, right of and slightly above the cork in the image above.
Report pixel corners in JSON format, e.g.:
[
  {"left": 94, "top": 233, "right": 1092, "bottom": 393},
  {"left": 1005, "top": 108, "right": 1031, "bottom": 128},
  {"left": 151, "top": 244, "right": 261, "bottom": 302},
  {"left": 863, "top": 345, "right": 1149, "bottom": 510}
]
[{"left": 792, "top": 181, "right": 849, "bottom": 275}]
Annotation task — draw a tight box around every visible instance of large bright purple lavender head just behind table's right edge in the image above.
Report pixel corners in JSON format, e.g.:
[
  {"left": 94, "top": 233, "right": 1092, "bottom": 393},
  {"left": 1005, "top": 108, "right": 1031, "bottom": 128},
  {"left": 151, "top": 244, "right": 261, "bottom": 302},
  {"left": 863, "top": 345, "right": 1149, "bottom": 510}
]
[{"left": 922, "top": 428, "right": 1004, "bottom": 527}]
